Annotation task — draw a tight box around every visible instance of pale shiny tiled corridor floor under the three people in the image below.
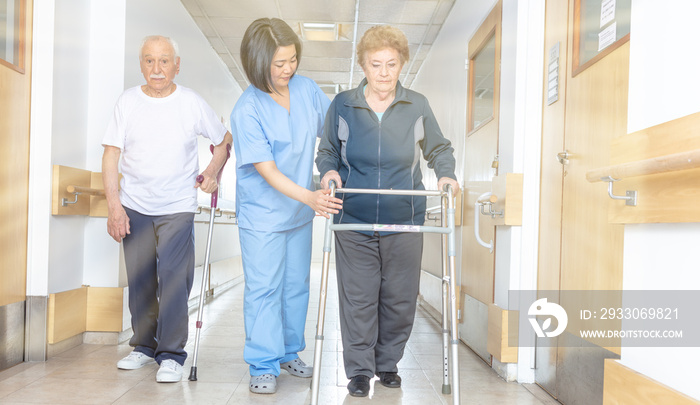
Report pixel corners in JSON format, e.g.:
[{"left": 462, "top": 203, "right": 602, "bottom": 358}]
[{"left": 0, "top": 264, "right": 556, "bottom": 405}]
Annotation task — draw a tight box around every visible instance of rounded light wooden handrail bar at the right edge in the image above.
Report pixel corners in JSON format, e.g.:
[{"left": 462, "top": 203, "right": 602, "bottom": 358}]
[{"left": 586, "top": 149, "right": 700, "bottom": 183}]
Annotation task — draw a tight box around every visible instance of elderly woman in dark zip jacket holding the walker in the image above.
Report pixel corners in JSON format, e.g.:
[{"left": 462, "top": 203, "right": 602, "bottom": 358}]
[{"left": 316, "top": 26, "right": 459, "bottom": 396}]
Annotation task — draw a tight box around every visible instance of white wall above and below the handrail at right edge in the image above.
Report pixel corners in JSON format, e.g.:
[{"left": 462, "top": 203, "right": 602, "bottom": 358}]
[{"left": 621, "top": 0, "right": 700, "bottom": 399}]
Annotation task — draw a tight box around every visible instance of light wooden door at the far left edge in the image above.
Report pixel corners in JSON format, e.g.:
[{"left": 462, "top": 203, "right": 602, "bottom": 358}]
[{"left": 0, "top": 1, "right": 31, "bottom": 370}]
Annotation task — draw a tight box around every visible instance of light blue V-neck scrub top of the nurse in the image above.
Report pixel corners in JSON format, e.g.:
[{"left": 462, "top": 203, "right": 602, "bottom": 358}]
[{"left": 231, "top": 75, "right": 330, "bottom": 232}]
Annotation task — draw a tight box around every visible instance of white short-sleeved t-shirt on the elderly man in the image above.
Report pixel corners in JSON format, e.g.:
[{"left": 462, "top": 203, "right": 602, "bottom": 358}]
[{"left": 102, "top": 85, "right": 226, "bottom": 215}]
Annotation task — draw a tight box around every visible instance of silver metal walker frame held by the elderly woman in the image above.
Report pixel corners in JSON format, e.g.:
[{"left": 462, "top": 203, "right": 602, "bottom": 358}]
[{"left": 311, "top": 181, "right": 459, "bottom": 405}]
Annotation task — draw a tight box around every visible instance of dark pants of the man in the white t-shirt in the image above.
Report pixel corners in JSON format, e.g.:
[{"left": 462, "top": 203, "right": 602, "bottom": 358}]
[{"left": 124, "top": 208, "right": 194, "bottom": 365}]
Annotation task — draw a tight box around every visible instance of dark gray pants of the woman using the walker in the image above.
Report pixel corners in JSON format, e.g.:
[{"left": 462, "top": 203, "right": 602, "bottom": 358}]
[{"left": 335, "top": 231, "right": 423, "bottom": 378}]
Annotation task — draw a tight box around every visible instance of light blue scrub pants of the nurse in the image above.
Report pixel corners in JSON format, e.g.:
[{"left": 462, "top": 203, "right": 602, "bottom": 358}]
[{"left": 239, "top": 222, "right": 312, "bottom": 376}]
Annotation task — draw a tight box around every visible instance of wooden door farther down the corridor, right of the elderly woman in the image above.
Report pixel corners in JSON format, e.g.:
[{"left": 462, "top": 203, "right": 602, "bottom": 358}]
[{"left": 460, "top": 2, "right": 501, "bottom": 364}]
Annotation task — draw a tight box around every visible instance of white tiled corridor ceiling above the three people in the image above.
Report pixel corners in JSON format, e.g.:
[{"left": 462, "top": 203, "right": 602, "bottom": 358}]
[{"left": 181, "top": 0, "right": 455, "bottom": 92}]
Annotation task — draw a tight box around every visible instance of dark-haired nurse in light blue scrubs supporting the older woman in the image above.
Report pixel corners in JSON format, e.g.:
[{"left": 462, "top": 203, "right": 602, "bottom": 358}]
[{"left": 231, "top": 18, "right": 342, "bottom": 394}]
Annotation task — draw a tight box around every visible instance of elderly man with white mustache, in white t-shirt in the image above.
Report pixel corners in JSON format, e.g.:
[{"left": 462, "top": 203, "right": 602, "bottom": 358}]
[{"left": 102, "top": 36, "right": 232, "bottom": 382}]
